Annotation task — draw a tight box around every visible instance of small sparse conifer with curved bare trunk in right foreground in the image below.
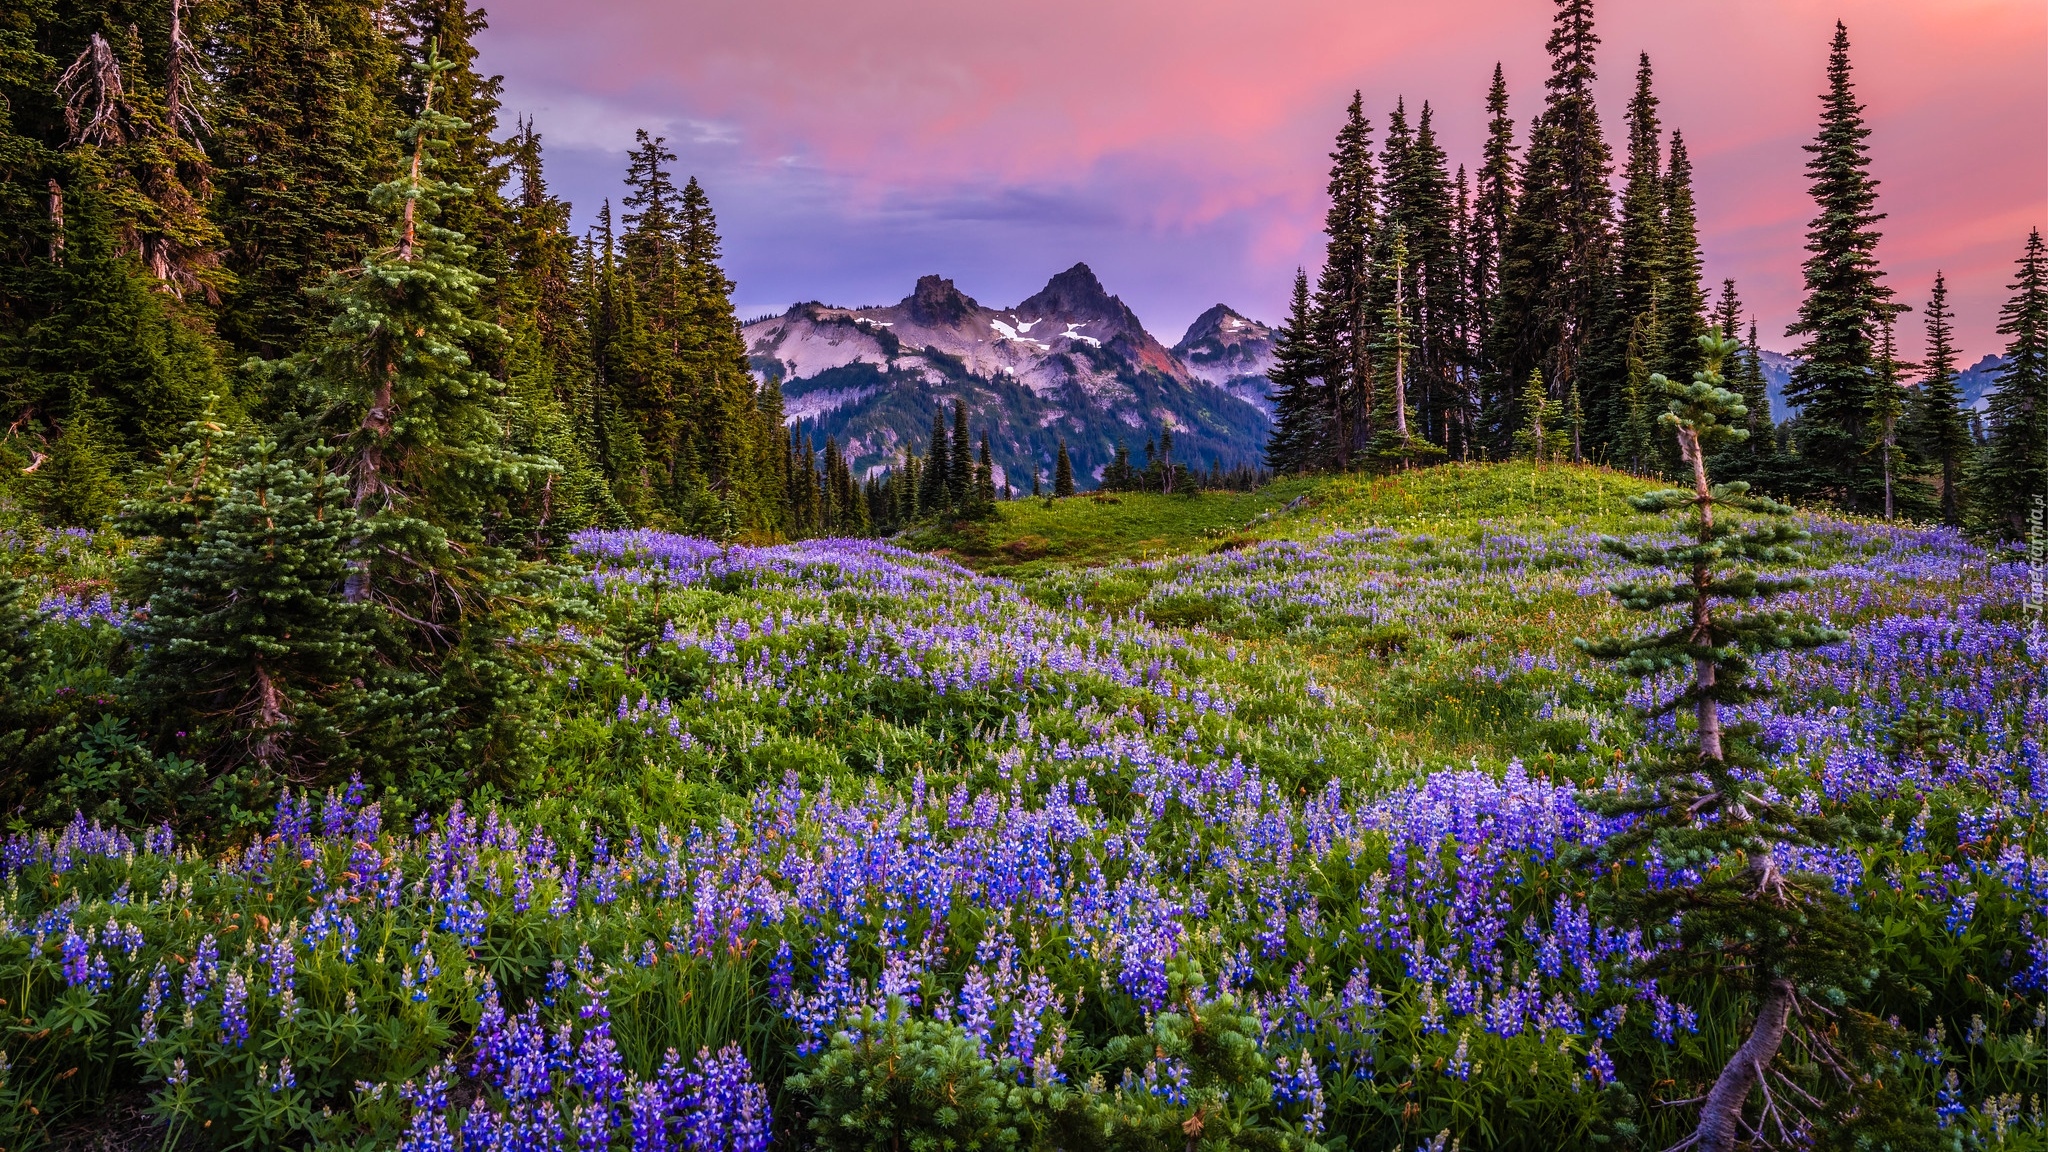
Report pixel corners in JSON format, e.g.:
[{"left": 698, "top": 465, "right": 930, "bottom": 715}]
[{"left": 1579, "top": 336, "right": 1868, "bottom": 1152}]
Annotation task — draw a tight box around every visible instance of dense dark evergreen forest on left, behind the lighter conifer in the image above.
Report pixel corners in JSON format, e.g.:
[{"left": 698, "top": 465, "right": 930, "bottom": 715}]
[{"left": 0, "top": 0, "right": 843, "bottom": 537}]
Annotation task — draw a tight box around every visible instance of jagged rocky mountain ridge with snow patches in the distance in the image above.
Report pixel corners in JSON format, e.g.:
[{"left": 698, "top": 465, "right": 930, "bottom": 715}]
[{"left": 741, "top": 264, "right": 1272, "bottom": 490}]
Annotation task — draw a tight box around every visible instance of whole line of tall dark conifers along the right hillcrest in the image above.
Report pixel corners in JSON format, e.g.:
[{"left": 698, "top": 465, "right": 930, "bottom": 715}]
[{"left": 1268, "top": 0, "right": 2048, "bottom": 539}]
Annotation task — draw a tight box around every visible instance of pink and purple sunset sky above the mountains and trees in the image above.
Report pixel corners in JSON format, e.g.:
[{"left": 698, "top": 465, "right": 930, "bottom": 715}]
[{"left": 481, "top": 0, "right": 2048, "bottom": 363}]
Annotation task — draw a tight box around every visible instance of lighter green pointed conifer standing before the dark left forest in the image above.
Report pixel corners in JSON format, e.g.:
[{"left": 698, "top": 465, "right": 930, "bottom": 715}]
[{"left": 266, "top": 53, "right": 559, "bottom": 797}]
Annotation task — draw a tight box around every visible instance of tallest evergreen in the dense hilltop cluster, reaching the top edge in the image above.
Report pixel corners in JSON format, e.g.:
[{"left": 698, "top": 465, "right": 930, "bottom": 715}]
[{"left": 1489, "top": 0, "right": 1618, "bottom": 457}]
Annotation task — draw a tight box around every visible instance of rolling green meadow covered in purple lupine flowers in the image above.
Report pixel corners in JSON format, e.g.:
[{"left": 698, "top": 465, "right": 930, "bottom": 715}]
[{"left": 0, "top": 465, "right": 2048, "bottom": 1152}]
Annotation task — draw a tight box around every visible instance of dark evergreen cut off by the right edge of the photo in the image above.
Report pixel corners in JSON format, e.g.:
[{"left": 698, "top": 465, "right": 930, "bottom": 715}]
[{"left": 1970, "top": 228, "right": 2048, "bottom": 539}]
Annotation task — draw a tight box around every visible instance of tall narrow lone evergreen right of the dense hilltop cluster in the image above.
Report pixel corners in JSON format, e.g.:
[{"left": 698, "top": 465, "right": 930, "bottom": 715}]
[{"left": 1786, "top": 23, "right": 1892, "bottom": 512}]
